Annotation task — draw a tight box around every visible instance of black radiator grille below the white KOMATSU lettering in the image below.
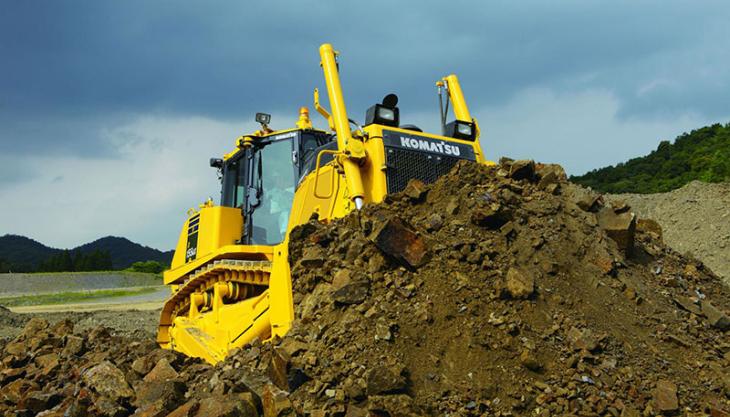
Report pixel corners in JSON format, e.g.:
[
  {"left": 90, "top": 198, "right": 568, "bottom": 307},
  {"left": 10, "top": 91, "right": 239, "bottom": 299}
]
[{"left": 385, "top": 146, "right": 460, "bottom": 194}]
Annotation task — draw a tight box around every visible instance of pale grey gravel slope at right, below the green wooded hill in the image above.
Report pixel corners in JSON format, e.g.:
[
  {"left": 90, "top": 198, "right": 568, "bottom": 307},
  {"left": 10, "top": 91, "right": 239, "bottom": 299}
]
[{"left": 609, "top": 181, "right": 730, "bottom": 284}]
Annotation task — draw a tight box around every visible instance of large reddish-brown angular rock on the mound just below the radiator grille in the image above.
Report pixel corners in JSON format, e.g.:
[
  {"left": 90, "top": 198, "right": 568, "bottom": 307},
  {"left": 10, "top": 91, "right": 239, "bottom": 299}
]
[{"left": 370, "top": 217, "right": 428, "bottom": 269}]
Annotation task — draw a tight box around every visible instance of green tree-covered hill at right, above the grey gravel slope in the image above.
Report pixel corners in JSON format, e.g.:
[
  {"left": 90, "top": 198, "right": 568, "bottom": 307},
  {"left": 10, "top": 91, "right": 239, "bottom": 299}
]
[{"left": 570, "top": 123, "right": 730, "bottom": 194}]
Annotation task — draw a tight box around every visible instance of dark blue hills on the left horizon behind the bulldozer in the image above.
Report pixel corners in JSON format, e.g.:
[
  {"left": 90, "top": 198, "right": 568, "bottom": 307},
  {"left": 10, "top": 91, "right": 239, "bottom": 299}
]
[{"left": 0, "top": 235, "right": 173, "bottom": 272}]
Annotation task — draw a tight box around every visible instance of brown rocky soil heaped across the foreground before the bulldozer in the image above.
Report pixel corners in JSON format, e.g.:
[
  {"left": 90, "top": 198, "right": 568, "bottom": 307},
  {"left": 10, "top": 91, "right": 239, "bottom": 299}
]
[{"left": 0, "top": 160, "right": 730, "bottom": 417}]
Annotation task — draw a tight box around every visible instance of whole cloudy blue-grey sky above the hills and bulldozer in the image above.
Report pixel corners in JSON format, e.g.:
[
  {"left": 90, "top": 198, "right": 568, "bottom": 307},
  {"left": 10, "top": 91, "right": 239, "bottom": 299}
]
[{"left": 0, "top": 0, "right": 730, "bottom": 249}]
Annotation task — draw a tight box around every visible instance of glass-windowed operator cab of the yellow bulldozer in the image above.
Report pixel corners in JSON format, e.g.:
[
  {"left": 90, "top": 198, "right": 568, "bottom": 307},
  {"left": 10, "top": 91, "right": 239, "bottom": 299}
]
[{"left": 211, "top": 114, "right": 336, "bottom": 245}]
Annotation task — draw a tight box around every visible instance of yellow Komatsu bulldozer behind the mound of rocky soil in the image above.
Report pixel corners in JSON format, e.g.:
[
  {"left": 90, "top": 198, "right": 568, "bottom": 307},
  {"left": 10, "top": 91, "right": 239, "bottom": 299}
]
[{"left": 157, "top": 44, "right": 487, "bottom": 364}]
